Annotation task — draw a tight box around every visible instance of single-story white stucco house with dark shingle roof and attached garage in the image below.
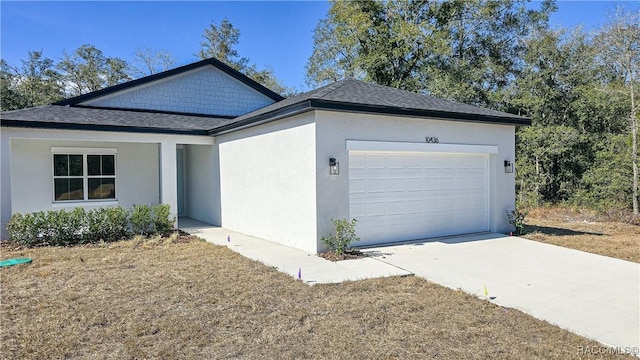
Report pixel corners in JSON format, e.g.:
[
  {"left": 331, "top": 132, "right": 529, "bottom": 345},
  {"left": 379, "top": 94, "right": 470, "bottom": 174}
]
[{"left": 0, "top": 59, "right": 530, "bottom": 253}]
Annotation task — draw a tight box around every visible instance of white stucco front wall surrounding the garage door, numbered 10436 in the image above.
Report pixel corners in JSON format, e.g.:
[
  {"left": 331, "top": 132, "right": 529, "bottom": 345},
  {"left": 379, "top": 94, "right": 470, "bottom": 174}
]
[{"left": 315, "top": 111, "right": 515, "bottom": 248}]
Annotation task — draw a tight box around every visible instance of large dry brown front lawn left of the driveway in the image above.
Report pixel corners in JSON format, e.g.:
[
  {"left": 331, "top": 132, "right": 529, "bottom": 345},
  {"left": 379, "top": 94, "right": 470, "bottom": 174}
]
[{"left": 0, "top": 241, "right": 633, "bottom": 359}]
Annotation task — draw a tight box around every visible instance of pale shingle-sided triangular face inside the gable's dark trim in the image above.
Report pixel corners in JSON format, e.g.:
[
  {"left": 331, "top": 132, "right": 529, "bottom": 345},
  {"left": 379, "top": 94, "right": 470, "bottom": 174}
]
[{"left": 83, "top": 66, "right": 274, "bottom": 116}]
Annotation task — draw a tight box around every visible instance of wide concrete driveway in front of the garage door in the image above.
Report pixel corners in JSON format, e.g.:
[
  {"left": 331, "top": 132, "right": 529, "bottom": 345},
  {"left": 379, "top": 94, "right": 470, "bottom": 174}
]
[{"left": 363, "top": 234, "right": 640, "bottom": 354}]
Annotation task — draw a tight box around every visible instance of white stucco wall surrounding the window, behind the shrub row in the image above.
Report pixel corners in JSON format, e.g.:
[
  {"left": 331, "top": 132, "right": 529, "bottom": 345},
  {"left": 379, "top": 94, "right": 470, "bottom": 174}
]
[{"left": 11, "top": 139, "right": 159, "bottom": 213}]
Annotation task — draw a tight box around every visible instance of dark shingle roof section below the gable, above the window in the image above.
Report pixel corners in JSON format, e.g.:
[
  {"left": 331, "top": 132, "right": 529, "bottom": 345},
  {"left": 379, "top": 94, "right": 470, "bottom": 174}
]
[{"left": 0, "top": 105, "right": 233, "bottom": 135}]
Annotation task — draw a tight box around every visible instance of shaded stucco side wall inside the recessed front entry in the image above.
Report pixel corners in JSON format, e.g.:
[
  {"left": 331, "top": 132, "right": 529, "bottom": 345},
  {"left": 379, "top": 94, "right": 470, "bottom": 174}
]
[{"left": 185, "top": 145, "right": 222, "bottom": 226}]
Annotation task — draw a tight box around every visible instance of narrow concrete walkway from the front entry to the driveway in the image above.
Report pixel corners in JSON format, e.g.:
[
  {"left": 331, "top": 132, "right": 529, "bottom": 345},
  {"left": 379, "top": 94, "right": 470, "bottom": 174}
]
[{"left": 179, "top": 218, "right": 412, "bottom": 285}]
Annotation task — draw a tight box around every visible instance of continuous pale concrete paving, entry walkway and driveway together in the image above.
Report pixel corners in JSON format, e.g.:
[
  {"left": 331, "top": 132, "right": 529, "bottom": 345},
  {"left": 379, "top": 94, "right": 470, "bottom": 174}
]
[{"left": 180, "top": 218, "right": 640, "bottom": 351}]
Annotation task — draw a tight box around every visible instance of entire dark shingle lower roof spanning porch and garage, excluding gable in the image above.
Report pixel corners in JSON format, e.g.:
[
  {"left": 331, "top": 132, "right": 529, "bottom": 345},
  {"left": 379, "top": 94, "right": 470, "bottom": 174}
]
[{"left": 1, "top": 80, "right": 531, "bottom": 135}]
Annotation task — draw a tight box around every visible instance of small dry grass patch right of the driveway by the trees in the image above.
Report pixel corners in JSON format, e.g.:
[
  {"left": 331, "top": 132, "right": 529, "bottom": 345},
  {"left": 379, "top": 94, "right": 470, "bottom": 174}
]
[{"left": 523, "top": 207, "right": 640, "bottom": 263}]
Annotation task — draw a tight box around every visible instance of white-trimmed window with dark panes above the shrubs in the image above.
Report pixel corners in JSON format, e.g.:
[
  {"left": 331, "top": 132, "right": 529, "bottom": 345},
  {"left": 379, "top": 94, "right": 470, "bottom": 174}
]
[{"left": 52, "top": 148, "right": 116, "bottom": 202}]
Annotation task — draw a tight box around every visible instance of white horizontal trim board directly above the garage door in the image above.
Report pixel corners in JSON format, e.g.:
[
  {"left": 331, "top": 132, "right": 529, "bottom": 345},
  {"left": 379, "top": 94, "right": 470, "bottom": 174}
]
[{"left": 347, "top": 140, "right": 498, "bottom": 154}]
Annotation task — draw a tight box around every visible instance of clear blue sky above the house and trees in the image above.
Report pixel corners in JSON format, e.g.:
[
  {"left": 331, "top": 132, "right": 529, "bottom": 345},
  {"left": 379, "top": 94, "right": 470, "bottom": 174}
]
[{"left": 0, "top": 0, "right": 640, "bottom": 90}]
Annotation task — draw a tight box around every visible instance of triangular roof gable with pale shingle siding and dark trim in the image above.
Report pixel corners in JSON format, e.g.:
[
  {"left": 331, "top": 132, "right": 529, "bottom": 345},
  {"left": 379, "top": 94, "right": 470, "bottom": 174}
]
[{"left": 55, "top": 59, "right": 283, "bottom": 116}]
